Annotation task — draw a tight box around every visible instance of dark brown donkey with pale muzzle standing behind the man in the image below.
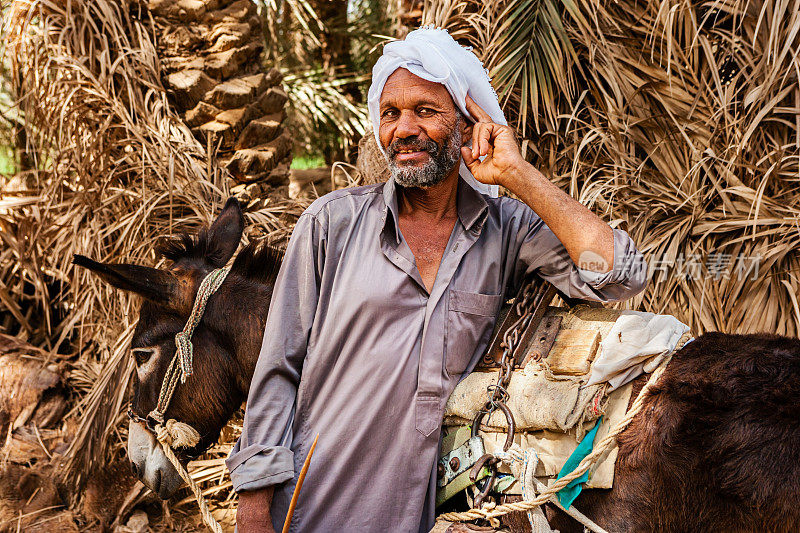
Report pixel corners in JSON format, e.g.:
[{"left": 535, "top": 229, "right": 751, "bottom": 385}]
[{"left": 76, "top": 200, "right": 800, "bottom": 533}]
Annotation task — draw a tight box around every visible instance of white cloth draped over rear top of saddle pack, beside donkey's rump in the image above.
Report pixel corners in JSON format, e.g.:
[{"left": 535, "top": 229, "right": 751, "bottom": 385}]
[{"left": 586, "top": 311, "right": 689, "bottom": 390}]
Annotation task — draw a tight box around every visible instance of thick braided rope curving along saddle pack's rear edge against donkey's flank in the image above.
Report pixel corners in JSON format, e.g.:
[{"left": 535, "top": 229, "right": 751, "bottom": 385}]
[{"left": 438, "top": 332, "right": 692, "bottom": 522}]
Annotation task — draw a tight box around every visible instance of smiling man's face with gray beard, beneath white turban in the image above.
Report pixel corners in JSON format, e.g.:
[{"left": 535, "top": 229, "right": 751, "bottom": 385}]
[{"left": 378, "top": 68, "right": 467, "bottom": 187}]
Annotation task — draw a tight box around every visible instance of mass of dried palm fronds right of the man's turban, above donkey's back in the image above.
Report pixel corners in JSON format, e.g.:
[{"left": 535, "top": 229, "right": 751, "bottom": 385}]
[{"left": 428, "top": 0, "right": 800, "bottom": 335}]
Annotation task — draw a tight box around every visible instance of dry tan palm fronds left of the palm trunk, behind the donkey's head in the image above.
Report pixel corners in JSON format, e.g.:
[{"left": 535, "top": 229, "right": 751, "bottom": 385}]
[{"left": 0, "top": 0, "right": 302, "bottom": 494}]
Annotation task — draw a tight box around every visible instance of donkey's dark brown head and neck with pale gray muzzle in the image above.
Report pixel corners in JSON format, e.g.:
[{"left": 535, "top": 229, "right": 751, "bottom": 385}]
[{"left": 75, "top": 199, "right": 281, "bottom": 498}]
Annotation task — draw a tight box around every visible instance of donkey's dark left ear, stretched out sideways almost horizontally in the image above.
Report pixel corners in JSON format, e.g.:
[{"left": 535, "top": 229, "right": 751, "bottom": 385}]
[{"left": 72, "top": 254, "right": 183, "bottom": 309}]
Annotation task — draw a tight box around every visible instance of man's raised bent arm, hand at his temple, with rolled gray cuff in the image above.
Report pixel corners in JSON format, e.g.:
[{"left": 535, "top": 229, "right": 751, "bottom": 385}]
[{"left": 461, "top": 96, "right": 647, "bottom": 301}]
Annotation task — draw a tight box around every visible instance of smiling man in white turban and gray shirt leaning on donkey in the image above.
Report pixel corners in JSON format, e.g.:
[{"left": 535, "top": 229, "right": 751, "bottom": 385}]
[{"left": 228, "top": 29, "right": 646, "bottom": 533}]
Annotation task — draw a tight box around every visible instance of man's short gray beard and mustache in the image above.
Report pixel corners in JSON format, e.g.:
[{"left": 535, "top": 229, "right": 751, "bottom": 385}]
[{"left": 386, "top": 125, "right": 462, "bottom": 188}]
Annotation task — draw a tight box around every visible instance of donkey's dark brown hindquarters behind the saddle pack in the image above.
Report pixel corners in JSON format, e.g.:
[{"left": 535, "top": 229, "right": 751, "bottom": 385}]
[{"left": 549, "top": 333, "right": 800, "bottom": 533}]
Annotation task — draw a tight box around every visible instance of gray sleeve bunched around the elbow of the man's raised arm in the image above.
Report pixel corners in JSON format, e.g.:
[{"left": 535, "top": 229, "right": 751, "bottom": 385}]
[{"left": 514, "top": 213, "right": 647, "bottom": 302}]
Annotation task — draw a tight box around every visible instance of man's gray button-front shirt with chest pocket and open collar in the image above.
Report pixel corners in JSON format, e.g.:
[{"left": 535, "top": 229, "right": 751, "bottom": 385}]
[{"left": 227, "top": 179, "right": 647, "bottom": 533}]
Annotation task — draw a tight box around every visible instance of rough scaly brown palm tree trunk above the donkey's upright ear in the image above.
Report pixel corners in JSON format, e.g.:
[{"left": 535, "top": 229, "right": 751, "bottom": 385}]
[{"left": 148, "top": 0, "right": 292, "bottom": 196}]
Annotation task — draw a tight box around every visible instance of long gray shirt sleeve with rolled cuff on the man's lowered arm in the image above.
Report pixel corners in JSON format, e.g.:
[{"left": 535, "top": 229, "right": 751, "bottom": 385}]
[{"left": 225, "top": 213, "right": 325, "bottom": 492}]
